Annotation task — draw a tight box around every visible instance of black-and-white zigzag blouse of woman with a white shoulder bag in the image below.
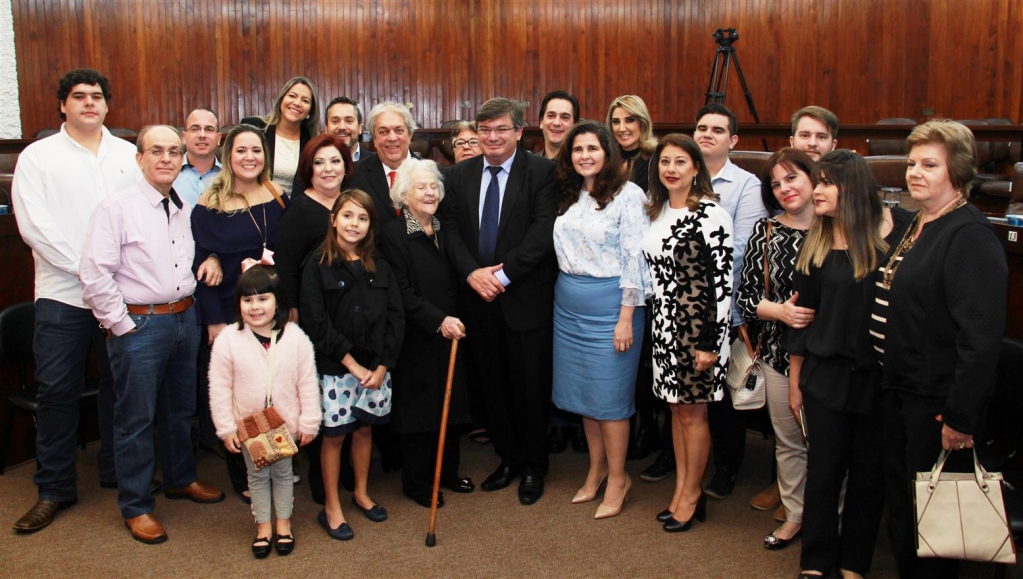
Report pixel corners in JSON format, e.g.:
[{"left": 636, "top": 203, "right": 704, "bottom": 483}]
[{"left": 736, "top": 218, "right": 806, "bottom": 375}]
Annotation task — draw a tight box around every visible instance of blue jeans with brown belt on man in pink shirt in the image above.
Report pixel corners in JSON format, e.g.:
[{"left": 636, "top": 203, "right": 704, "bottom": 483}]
[{"left": 107, "top": 308, "right": 198, "bottom": 519}]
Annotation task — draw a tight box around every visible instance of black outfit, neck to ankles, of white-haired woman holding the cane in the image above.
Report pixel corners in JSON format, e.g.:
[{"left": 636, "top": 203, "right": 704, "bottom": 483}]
[{"left": 380, "top": 212, "right": 470, "bottom": 497}]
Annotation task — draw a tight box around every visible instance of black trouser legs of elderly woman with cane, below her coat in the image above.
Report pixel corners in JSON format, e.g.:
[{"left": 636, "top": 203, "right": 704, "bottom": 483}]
[{"left": 399, "top": 427, "right": 462, "bottom": 497}]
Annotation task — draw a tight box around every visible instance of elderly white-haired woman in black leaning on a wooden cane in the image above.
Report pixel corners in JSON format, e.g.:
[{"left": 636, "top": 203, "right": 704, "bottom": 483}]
[{"left": 380, "top": 159, "right": 476, "bottom": 508}]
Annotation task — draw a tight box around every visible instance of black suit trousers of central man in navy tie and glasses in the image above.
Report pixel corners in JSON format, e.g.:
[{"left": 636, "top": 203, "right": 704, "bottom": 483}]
[{"left": 465, "top": 303, "right": 553, "bottom": 477}]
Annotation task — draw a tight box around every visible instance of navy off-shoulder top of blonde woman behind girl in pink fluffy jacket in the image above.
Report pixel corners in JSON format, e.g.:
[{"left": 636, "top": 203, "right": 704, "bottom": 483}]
[{"left": 191, "top": 197, "right": 287, "bottom": 325}]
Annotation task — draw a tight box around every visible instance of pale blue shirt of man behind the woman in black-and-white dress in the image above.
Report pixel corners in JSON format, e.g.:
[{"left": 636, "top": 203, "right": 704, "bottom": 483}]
[{"left": 710, "top": 160, "right": 767, "bottom": 325}]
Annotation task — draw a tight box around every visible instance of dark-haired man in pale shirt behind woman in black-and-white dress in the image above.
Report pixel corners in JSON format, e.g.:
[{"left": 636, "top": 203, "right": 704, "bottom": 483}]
[{"left": 693, "top": 103, "right": 767, "bottom": 498}]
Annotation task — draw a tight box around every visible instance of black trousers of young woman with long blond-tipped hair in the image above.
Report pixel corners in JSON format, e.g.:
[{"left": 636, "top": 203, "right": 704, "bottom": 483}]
[{"left": 800, "top": 397, "right": 885, "bottom": 575}]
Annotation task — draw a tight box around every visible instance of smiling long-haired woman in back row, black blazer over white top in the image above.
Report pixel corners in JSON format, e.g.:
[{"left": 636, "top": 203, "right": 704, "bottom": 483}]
[{"left": 241, "top": 77, "right": 319, "bottom": 196}]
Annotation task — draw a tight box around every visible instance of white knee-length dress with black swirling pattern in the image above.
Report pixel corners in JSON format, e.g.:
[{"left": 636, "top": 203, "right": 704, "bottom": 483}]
[{"left": 643, "top": 199, "right": 732, "bottom": 404}]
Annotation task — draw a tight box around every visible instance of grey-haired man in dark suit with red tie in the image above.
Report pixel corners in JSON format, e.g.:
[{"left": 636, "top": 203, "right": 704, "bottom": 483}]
[{"left": 350, "top": 100, "right": 416, "bottom": 231}]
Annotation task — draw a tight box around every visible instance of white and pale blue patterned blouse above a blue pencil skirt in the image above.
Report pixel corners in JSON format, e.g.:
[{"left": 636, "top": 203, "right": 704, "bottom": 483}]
[{"left": 554, "top": 182, "right": 651, "bottom": 306}]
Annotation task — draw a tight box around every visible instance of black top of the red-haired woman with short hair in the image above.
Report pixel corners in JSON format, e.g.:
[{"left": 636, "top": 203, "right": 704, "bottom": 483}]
[{"left": 273, "top": 195, "right": 330, "bottom": 308}]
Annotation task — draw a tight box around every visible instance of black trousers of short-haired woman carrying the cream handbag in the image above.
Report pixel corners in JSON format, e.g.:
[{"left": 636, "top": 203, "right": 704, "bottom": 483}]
[{"left": 883, "top": 390, "right": 973, "bottom": 579}]
